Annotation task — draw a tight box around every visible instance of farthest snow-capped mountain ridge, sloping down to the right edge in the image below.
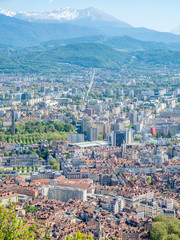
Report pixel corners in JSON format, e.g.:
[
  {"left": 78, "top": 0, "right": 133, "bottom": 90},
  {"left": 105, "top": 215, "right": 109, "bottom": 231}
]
[{"left": 7, "top": 7, "right": 180, "bottom": 43}]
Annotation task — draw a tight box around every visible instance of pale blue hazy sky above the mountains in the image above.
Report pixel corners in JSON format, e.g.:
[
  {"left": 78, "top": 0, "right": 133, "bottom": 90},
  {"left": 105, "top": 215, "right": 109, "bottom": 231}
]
[{"left": 0, "top": 0, "right": 180, "bottom": 31}]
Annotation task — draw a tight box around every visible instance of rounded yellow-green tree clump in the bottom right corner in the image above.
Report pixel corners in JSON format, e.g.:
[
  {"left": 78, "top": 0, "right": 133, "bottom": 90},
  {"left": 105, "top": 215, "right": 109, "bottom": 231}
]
[{"left": 151, "top": 214, "right": 180, "bottom": 240}]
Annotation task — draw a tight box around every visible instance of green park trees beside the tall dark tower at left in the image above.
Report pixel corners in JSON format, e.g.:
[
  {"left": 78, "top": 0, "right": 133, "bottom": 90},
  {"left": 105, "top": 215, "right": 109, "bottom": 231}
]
[{"left": 0, "top": 119, "right": 74, "bottom": 146}]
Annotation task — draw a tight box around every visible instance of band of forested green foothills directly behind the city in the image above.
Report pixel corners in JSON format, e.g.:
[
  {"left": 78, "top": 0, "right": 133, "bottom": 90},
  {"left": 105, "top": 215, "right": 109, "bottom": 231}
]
[{"left": 0, "top": 43, "right": 180, "bottom": 74}]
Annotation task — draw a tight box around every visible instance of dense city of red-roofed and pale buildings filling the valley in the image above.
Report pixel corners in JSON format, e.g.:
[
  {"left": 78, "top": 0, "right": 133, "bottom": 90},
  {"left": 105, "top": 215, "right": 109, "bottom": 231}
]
[{"left": 0, "top": 63, "right": 180, "bottom": 240}]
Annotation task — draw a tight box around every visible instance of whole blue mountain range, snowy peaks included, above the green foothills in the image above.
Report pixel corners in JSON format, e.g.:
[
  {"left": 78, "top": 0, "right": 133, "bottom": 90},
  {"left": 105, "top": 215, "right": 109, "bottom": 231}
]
[{"left": 0, "top": 8, "right": 180, "bottom": 46}]
